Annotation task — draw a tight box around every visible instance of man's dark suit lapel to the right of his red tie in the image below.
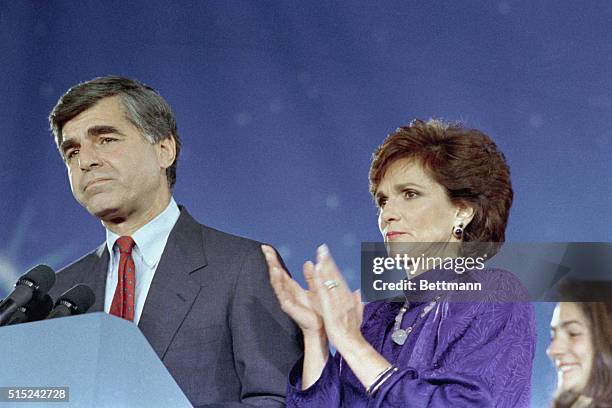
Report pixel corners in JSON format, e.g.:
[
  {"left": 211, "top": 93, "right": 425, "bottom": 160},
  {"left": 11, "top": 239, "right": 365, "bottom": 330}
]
[{"left": 138, "top": 207, "right": 206, "bottom": 358}]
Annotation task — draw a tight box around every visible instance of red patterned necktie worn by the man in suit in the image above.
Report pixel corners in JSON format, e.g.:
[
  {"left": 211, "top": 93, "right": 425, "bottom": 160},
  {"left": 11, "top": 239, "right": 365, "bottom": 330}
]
[{"left": 110, "top": 237, "right": 136, "bottom": 321}]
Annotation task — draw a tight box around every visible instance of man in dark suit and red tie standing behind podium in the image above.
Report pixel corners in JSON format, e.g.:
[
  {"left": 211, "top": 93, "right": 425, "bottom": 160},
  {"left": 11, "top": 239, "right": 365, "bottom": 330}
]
[{"left": 49, "top": 77, "right": 301, "bottom": 407}]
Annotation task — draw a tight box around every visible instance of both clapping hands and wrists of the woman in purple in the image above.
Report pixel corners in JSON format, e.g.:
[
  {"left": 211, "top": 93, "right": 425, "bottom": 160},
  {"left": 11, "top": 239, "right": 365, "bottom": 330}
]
[{"left": 261, "top": 245, "right": 389, "bottom": 390}]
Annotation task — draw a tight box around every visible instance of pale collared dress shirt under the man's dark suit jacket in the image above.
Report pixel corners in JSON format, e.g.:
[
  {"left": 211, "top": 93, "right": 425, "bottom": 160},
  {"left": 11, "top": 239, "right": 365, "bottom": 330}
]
[{"left": 104, "top": 198, "right": 181, "bottom": 324}]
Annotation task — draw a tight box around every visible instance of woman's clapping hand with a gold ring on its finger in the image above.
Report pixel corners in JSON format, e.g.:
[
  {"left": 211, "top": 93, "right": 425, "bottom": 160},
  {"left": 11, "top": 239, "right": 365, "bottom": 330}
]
[{"left": 313, "top": 245, "right": 366, "bottom": 354}]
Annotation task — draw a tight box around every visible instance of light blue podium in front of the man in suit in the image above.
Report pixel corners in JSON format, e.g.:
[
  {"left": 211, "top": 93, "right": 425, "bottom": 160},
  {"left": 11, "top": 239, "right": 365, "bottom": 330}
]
[{"left": 0, "top": 313, "right": 192, "bottom": 408}]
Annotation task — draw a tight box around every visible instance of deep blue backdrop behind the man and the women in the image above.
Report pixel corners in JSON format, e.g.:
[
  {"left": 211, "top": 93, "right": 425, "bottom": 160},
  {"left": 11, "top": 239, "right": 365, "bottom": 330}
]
[{"left": 0, "top": 0, "right": 612, "bottom": 407}]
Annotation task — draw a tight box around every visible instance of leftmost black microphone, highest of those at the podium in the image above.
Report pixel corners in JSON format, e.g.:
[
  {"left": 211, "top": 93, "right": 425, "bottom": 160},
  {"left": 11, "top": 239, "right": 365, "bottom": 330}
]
[{"left": 0, "top": 265, "right": 55, "bottom": 326}]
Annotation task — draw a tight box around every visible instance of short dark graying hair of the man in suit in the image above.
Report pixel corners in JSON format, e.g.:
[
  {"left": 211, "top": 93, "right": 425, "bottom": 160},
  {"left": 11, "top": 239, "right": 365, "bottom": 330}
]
[{"left": 49, "top": 76, "right": 181, "bottom": 188}]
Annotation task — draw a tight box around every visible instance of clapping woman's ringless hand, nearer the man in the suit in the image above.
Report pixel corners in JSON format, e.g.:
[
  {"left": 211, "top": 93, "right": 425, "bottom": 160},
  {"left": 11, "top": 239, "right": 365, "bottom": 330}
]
[{"left": 261, "top": 245, "right": 325, "bottom": 338}]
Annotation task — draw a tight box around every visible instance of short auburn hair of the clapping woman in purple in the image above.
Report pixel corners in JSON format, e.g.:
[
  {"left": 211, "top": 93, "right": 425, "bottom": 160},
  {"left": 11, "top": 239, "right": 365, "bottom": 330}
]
[{"left": 369, "top": 119, "right": 513, "bottom": 255}]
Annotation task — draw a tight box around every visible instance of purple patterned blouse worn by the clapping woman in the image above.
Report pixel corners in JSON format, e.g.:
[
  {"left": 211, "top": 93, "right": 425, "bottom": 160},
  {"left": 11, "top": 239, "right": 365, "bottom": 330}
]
[{"left": 287, "top": 269, "right": 535, "bottom": 408}]
